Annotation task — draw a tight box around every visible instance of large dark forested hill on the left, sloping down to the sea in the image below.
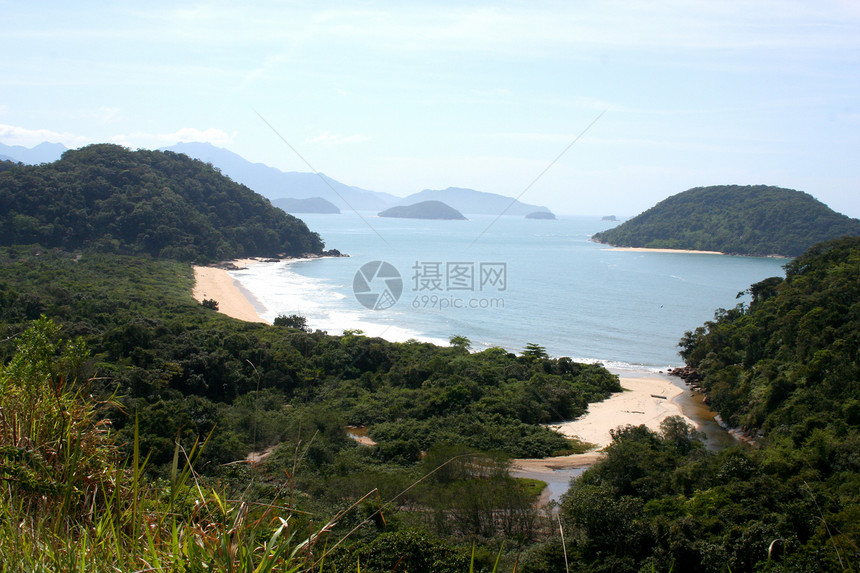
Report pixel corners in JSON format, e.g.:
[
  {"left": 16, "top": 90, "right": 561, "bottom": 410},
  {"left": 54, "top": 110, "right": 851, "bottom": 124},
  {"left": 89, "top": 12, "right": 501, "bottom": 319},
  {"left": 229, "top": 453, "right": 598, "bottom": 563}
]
[{"left": 0, "top": 144, "right": 323, "bottom": 262}]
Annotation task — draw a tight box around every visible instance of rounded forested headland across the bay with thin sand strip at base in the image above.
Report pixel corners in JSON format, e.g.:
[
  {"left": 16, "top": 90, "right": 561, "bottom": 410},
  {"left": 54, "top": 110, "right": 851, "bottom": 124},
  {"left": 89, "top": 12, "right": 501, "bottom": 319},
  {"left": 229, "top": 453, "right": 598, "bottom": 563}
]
[{"left": 592, "top": 185, "right": 860, "bottom": 257}]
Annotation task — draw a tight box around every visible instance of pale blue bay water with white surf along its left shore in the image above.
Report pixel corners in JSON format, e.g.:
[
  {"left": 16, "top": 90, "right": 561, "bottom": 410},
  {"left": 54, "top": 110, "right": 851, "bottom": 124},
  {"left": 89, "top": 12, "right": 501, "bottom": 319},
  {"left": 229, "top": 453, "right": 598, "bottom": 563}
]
[{"left": 230, "top": 213, "right": 786, "bottom": 371}]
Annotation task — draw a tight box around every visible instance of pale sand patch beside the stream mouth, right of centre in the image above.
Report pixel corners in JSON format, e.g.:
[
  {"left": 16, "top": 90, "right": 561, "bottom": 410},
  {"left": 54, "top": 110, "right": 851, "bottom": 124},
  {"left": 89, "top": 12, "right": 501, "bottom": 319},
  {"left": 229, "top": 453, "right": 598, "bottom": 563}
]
[{"left": 512, "top": 377, "right": 695, "bottom": 474}]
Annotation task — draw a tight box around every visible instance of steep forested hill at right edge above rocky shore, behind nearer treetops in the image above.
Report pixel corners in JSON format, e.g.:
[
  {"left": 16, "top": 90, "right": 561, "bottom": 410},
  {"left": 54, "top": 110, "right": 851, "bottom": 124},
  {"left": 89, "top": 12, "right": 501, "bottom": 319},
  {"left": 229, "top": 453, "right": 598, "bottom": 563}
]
[{"left": 681, "top": 237, "right": 860, "bottom": 436}]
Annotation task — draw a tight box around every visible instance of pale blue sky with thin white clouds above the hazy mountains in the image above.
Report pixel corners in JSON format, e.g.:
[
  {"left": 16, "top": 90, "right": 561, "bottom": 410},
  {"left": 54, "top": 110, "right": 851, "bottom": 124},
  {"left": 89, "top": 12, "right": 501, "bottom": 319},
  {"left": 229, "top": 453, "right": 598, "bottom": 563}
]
[{"left": 0, "top": 0, "right": 860, "bottom": 217}]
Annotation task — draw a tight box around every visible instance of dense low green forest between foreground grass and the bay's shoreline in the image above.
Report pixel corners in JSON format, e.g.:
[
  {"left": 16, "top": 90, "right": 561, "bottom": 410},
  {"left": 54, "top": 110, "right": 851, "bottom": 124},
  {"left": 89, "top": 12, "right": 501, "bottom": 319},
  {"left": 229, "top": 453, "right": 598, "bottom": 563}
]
[{"left": 0, "top": 247, "right": 620, "bottom": 571}]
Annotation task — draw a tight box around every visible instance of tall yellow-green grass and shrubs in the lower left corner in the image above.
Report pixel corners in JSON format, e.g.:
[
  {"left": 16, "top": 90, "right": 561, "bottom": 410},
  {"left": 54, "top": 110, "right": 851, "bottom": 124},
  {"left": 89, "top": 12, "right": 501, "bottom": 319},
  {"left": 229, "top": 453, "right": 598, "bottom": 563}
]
[{"left": 0, "top": 319, "right": 332, "bottom": 573}]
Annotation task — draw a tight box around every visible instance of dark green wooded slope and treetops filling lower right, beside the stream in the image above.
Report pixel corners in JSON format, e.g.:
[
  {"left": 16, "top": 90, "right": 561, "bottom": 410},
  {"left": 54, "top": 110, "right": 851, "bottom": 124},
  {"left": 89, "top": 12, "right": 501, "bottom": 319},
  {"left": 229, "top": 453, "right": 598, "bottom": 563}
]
[{"left": 540, "top": 238, "right": 860, "bottom": 573}]
